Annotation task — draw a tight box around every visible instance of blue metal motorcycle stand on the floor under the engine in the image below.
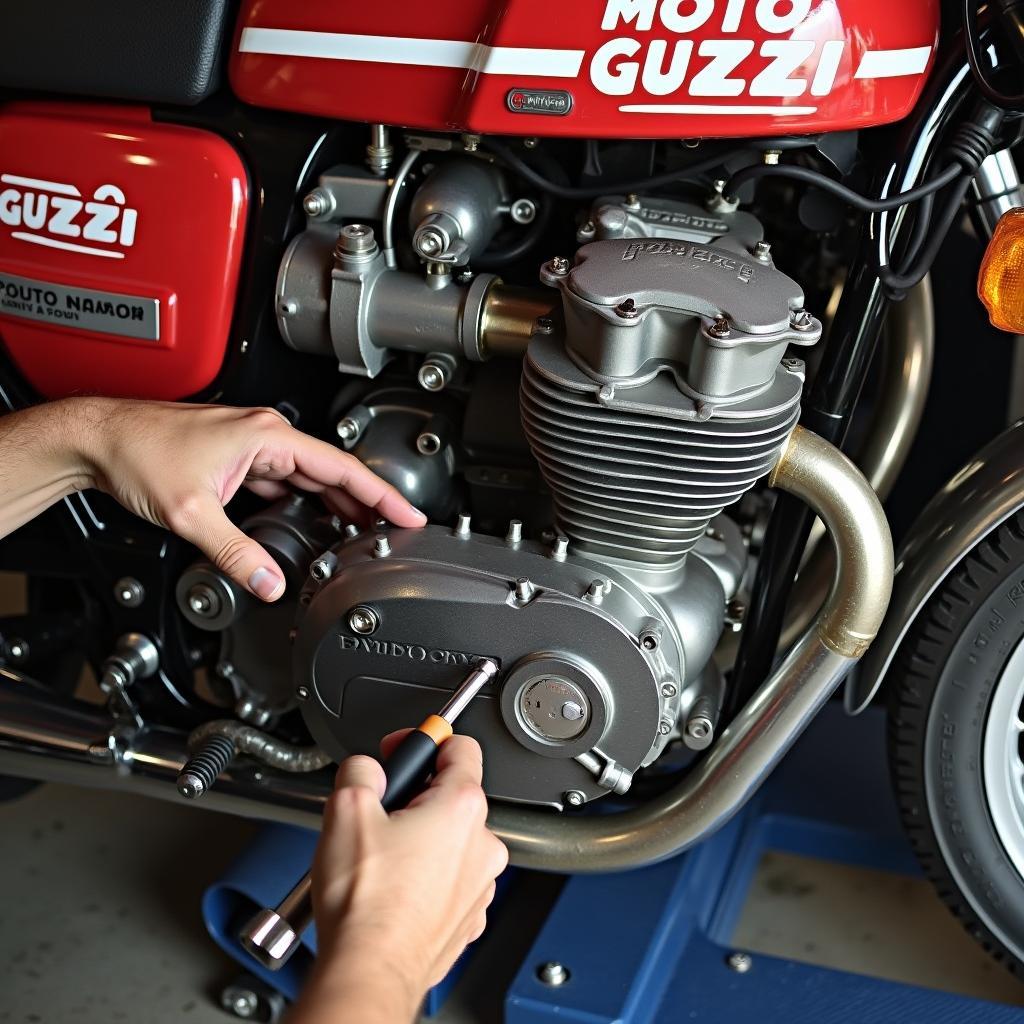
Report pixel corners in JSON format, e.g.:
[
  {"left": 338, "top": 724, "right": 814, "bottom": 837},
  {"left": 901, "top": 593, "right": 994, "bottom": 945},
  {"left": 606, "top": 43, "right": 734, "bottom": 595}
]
[{"left": 203, "top": 702, "right": 1024, "bottom": 1024}]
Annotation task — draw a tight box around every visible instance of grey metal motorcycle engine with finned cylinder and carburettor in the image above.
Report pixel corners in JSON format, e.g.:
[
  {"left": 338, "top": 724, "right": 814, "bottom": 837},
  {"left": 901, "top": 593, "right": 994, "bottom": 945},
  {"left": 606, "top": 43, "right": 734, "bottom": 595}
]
[{"left": 178, "top": 147, "right": 821, "bottom": 808}]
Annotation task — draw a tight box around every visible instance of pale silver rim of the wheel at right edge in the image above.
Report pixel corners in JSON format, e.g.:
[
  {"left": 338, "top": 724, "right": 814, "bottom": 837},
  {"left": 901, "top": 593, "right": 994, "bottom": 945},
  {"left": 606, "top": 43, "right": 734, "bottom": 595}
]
[{"left": 982, "top": 641, "right": 1024, "bottom": 880}]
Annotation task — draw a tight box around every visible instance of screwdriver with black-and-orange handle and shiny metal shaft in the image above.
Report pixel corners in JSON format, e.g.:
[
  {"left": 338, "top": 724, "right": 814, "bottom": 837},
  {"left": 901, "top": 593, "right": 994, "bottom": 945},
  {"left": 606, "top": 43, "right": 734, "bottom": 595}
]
[{"left": 239, "top": 657, "right": 498, "bottom": 971}]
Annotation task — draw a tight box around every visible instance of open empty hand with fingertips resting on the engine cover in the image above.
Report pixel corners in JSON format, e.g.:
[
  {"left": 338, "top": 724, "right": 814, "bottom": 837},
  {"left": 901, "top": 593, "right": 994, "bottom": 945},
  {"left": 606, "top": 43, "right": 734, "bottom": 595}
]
[{"left": 77, "top": 398, "right": 426, "bottom": 601}]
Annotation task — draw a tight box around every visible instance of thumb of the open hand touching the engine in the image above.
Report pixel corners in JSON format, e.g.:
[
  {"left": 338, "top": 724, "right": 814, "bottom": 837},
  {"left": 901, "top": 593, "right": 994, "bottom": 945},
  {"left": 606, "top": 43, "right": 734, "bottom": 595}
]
[{"left": 171, "top": 495, "right": 285, "bottom": 601}]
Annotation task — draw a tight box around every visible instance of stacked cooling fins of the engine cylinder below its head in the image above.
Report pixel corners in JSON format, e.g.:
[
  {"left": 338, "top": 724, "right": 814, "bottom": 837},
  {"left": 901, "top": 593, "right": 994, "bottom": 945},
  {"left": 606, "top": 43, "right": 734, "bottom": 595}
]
[{"left": 520, "top": 354, "right": 800, "bottom": 563}]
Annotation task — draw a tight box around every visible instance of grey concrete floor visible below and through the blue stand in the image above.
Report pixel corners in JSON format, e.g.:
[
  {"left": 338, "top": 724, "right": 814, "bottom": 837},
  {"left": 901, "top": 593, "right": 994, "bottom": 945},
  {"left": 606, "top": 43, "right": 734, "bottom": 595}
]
[{"left": 0, "top": 785, "right": 1024, "bottom": 1024}]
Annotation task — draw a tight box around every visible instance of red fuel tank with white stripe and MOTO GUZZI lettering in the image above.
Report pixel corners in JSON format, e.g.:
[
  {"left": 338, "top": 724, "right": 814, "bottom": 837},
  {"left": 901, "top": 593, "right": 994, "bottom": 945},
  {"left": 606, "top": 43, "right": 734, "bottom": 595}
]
[{"left": 230, "top": 0, "right": 939, "bottom": 138}]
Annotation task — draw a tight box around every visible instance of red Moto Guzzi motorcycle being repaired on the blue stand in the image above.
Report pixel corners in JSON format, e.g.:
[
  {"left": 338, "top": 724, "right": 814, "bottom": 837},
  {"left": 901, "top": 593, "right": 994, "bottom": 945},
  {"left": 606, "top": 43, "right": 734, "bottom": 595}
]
[{"left": 0, "top": 0, "right": 1024, "bottom": 983}]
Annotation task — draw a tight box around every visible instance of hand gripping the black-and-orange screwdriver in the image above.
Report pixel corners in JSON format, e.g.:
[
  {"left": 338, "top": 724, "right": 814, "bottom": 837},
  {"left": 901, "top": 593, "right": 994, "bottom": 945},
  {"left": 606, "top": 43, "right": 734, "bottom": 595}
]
[{"left": 299, "top": 733, "right": 508, "bottom": 1021}]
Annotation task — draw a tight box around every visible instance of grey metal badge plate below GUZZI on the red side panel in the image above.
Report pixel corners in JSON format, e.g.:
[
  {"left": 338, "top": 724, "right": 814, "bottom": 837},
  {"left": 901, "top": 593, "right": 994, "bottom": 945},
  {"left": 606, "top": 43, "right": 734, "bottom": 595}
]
[{"left": 0, "top": 273, "right": 160, "bottom": 341}]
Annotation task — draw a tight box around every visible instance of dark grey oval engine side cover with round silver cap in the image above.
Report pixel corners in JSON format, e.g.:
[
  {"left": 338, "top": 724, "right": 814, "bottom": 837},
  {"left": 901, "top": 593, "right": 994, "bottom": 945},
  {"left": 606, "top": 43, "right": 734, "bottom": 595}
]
[{"left": 294, "top": 526, "right": 684, "bottom": 806}]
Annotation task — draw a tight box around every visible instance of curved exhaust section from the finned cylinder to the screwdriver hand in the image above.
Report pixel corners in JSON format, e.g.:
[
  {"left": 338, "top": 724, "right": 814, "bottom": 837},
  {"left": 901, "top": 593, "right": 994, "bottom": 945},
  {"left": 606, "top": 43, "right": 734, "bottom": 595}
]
[{"left": 489, "top": 427, "right": 893, "bottom": 872}]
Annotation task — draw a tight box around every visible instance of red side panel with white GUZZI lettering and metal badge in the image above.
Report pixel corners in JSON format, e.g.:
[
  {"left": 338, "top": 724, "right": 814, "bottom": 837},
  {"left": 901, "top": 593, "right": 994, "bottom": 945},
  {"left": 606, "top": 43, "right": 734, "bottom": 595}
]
[{"left": 0, "top": 103, "right": 248, "bottom": 399}]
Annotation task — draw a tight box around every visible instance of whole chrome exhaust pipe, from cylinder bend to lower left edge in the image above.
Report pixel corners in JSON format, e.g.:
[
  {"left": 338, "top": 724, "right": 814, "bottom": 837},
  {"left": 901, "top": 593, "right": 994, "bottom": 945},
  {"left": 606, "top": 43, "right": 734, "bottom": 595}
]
[{"left": 0, "top": 427, "right": 893, "bottom": 872}]
